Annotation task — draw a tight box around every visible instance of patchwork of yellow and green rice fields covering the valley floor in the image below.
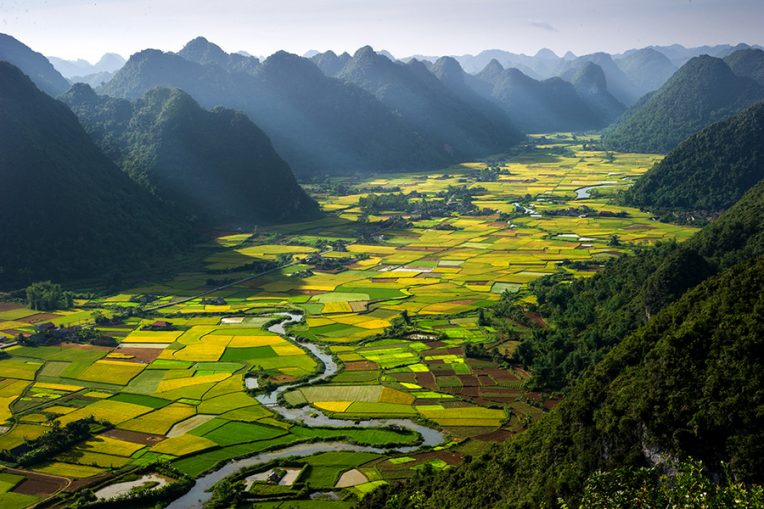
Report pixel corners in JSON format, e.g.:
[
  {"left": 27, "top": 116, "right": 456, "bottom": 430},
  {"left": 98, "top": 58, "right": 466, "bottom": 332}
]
[{"left": 0, "top": 135, "right": 694, "bottom": 507}]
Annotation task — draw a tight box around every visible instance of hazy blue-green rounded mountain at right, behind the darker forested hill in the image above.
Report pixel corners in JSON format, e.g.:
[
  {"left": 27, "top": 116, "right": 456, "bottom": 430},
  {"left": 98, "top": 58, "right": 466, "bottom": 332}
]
[{"left": 602, "top": 55, "right": 764, "bottom": 153}]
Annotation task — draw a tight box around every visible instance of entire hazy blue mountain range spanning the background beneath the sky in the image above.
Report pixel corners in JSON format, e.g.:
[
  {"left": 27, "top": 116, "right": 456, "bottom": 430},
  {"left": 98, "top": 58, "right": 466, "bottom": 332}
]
[{"left": 0, "top": 31, "right": 764, "bottom": 171}]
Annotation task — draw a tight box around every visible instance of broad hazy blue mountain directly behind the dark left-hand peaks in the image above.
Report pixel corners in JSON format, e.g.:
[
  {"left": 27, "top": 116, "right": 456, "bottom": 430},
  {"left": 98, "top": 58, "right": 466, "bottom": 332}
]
[{"left": 98, "top": 39, "right": 454, "bottom": 175}]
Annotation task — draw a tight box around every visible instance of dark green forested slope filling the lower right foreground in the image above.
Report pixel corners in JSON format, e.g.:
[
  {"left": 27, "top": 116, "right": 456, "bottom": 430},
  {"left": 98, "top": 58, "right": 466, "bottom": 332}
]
[{"left": 361, "top": 176, "right": 764, "bottom": 509}]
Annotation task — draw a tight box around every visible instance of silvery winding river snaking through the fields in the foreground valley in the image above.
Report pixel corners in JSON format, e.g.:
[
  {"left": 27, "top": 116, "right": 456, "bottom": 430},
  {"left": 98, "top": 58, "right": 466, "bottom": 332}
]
[{"left": 168, "top": 313, "right": 445, "bottom": 509}]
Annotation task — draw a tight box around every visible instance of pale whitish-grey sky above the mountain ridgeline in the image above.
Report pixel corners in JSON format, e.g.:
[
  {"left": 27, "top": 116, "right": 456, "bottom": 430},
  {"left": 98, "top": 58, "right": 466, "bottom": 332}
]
[{"left": 0, "top": 0, "right": 764, "bottom": 61}]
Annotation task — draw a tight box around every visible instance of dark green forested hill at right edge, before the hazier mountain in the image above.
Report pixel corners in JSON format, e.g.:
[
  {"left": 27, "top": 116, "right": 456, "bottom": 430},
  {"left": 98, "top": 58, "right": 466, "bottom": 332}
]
[{"left": 625, "top": 102, "right": 764, "bottom": 212}]
